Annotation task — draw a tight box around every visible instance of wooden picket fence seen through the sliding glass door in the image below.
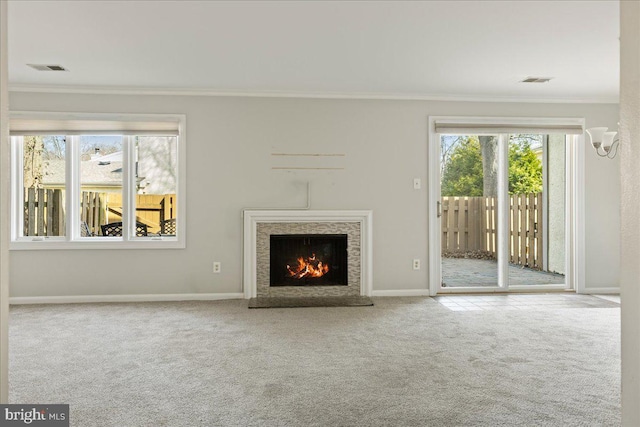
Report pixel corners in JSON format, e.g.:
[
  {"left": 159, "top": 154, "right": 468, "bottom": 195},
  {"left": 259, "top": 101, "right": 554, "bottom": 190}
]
[{"left": 441, "top": 193, "right": 543, "bottom": 270}]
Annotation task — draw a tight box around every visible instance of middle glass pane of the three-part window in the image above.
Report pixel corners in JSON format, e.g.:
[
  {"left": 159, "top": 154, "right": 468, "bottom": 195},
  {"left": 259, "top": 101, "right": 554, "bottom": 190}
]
[{"left": 80, "top": 136, "right": 123, "bottom": 237}]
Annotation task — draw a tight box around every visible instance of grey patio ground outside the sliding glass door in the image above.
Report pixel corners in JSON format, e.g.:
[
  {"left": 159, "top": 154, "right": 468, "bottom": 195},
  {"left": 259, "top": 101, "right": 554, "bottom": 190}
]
[{"left": 442, "top": 258, "right": 564, "bottom": 288}]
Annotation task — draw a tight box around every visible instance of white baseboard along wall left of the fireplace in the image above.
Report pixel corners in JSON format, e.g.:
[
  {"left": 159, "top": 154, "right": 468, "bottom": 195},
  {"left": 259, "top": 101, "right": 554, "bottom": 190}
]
[{"left": 9, "top": 292, "right": 244, "bottom": 305}]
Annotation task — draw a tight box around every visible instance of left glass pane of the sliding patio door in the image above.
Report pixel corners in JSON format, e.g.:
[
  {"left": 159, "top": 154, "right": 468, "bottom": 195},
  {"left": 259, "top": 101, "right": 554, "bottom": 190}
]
[{"left": 440, "top": 135, "right": 498, "bottom": 287}]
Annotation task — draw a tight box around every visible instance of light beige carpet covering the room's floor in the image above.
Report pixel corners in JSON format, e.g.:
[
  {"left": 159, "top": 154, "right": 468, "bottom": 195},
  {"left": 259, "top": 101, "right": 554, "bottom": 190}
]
[{"left": 9, "top": 295, "right": 620, "bottom": 427}]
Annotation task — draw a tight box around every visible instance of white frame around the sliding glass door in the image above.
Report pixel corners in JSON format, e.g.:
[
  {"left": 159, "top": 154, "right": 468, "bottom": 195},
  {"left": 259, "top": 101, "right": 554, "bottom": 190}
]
[{"left": 427, "top": 116, "right": 585, "bottom": 296}]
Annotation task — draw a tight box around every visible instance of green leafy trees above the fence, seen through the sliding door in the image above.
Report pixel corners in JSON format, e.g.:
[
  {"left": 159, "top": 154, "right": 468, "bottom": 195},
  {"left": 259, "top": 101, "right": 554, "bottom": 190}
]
[{"left": 442, "top": 135, "right": 542, "bottom": 197}]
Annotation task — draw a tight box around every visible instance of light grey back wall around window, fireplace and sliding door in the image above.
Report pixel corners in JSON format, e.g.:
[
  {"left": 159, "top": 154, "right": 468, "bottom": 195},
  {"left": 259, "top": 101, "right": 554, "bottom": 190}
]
[{"left": 5, "top": 93, "right": 619, "bottom": 297}]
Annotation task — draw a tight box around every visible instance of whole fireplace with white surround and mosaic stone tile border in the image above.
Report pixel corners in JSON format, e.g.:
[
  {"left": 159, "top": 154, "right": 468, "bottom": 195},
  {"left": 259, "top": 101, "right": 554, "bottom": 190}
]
[{"left": 243, "top": 210, "right": 373, "bottom": 299}]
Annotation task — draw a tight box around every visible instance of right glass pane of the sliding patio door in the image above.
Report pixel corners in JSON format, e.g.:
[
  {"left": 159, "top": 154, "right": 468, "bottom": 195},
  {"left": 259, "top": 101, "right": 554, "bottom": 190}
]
[{"left": 509, "top": 135, "right": 566, "bottom": 286}]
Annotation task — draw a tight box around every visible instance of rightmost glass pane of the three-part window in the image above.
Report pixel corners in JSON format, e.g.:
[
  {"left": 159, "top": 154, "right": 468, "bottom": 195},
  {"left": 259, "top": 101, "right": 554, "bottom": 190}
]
[{"left": 135, "top": 136, "right": 178, "bottom": 236}]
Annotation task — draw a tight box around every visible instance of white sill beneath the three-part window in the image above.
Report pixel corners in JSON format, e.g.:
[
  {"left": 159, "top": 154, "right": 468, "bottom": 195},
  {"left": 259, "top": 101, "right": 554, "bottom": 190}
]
[{"left": 9, "top": 237, "right": 186, "bottom": 251}]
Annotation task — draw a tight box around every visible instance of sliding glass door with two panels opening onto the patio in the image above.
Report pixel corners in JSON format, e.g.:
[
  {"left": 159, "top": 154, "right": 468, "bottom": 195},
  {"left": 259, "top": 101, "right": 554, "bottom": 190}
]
[{"left": 436, "top": 133, "right": 568, "bottom": 290}]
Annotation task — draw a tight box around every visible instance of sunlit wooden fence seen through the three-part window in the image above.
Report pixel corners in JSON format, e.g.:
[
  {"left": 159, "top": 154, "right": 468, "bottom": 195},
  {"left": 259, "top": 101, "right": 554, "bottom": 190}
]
[{"left": 24, "top": 188, "right": 177, "bottom": 236}]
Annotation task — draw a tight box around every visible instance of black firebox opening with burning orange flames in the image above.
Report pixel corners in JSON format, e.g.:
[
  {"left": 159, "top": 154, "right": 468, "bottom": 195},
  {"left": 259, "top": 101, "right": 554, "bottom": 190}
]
[{"left": 269, "top": 234, "right": 348, "bottom": 286}]
